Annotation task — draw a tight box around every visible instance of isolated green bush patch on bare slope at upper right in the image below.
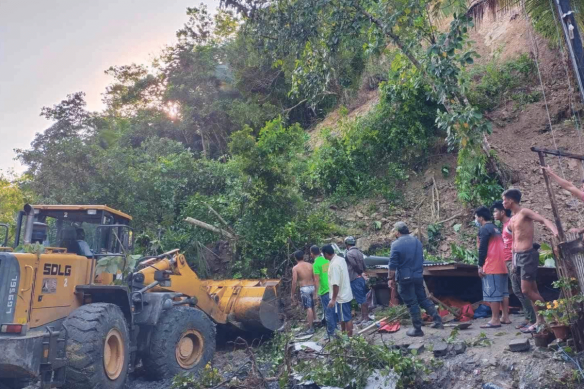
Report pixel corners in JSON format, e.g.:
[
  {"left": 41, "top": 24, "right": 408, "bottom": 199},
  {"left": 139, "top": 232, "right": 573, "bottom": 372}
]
[{"left": 467, "top": 53, "right": 541, "bottom": 111}]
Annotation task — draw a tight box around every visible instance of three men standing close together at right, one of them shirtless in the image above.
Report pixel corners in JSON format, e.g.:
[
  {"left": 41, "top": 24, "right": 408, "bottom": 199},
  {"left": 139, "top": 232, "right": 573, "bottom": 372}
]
[{"left": 475, "top": 189, "right": 558, "bottom": 332}]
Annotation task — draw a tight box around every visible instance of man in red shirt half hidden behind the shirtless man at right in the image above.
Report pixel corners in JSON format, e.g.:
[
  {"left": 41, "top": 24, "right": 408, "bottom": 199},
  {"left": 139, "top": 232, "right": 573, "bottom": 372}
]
[{"left": 492, "top": 200, "right": 535, "bottom": 330}]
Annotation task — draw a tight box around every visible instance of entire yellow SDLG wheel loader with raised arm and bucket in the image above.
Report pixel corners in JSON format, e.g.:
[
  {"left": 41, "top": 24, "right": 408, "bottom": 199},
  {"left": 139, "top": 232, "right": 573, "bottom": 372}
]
[{"left": 0, "top": 205, "right": 282, "bottom": 389}]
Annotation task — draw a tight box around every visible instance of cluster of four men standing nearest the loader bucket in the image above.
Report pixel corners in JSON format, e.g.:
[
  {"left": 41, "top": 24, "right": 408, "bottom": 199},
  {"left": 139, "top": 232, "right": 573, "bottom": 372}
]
[{"left": 292, "top": 236, "right": 369, "bottom": 337}]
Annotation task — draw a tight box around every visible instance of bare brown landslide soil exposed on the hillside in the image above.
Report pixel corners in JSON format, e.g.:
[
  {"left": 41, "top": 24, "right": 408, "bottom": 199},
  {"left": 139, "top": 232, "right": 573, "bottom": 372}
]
[{"left": 318, "top": 10, "right": 584, "bottom": 256}]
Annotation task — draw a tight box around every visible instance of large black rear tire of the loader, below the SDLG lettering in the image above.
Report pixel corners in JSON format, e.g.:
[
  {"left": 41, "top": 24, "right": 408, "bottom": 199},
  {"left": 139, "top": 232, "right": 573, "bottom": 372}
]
[{"left": 63, "top": 303, "right": 130, "bottom": 389}]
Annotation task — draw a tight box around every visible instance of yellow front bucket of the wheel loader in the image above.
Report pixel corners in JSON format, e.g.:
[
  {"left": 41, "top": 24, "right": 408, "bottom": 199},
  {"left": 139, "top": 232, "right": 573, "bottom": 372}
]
[{"left": 204, "top": 280, "right": 284, "bottom": 331}]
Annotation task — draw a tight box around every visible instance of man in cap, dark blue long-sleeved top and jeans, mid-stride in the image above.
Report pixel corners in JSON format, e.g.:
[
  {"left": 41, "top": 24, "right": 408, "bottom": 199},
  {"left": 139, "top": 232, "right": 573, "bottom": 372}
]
[{"left": 388, "top": 222, "right": 444, "bottom": 336}]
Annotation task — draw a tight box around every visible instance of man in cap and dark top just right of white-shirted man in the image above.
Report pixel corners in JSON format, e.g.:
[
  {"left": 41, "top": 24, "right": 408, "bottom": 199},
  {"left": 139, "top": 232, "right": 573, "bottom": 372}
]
[{"left": 345, "top": 236, "right": 369, "bottom": 324}]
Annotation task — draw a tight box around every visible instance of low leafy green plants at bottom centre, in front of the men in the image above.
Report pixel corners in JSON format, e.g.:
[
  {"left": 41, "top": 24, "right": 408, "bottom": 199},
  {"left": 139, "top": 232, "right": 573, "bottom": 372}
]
[{"left": 296, "top": 336, "right": 425, "bottom": 388}]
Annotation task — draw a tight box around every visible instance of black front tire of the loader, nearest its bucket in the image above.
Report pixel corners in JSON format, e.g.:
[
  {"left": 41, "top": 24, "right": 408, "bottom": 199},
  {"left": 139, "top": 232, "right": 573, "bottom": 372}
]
[{"left": 142, "top": 306, "right": 216, "bottom": 380}]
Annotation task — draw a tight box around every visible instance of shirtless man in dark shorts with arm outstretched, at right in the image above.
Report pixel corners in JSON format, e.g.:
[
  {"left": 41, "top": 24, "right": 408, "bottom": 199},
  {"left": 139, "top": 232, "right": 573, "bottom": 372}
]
[{"left": 503, "top": 189, "right": 558, "bottom": 332}]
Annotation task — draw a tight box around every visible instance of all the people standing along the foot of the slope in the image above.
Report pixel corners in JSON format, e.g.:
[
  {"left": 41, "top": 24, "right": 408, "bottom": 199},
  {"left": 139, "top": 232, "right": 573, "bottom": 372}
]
[{"left": 292, "top": 167, "right": 584, "bottom": 336}]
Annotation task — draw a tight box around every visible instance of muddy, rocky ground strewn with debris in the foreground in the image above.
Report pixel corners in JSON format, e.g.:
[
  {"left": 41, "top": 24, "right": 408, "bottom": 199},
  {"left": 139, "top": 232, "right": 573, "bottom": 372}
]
[{"left": 123, "top": 306, "right": 584, "bottom": 389}]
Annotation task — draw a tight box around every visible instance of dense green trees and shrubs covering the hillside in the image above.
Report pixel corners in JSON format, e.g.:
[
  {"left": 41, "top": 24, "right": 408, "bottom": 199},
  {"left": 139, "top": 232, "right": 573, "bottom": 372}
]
[{"left": 0, "top": 0, "right": 580, "bottom": 277}]
